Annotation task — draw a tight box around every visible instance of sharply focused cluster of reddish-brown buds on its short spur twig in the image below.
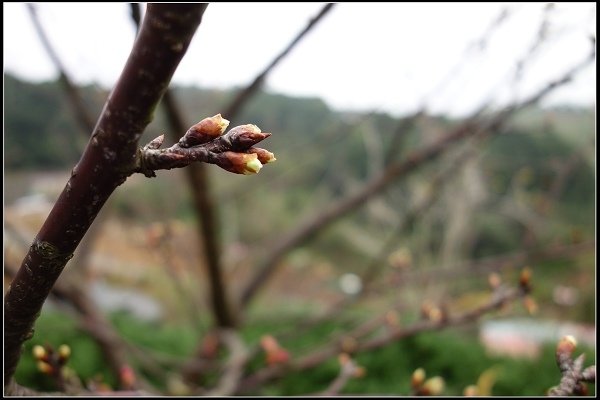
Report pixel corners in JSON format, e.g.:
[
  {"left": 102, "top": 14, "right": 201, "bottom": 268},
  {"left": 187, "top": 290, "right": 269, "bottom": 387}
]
[{"left": 134, "top": 114, "right": 276, "bottom": 177}]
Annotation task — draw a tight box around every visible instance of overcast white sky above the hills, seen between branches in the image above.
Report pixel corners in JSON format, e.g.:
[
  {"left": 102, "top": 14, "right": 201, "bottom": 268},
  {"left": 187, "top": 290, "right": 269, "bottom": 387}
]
[{"left": 3, "top": 3, "right": 596, "bottom": 115}]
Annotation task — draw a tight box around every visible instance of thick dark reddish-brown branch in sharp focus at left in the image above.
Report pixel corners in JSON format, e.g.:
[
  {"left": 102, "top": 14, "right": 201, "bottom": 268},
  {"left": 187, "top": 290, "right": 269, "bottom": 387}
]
[{"left": 4, "top": 4, "right": 206, "bottom": 387}]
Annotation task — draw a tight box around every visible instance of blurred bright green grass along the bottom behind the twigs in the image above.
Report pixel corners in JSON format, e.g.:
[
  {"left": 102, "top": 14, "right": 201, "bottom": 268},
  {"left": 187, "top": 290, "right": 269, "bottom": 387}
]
[{"left": 16, "top": 311, "right": 595, "bottom": 396}]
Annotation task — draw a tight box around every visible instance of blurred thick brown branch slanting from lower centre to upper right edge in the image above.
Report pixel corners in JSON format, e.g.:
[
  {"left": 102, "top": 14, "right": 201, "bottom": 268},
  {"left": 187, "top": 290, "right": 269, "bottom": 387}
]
[{"left": 240, "top": 49, "right": 595, "bottom": 306}]
